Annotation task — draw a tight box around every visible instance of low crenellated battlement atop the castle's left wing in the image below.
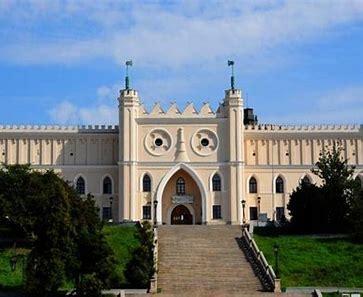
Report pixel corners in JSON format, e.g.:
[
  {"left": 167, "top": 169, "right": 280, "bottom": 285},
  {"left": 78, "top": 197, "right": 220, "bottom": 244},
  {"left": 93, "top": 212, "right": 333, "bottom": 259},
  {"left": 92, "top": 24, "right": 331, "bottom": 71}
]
[{"left": 0, "top": 125, "right": 118, "bottom": 133}]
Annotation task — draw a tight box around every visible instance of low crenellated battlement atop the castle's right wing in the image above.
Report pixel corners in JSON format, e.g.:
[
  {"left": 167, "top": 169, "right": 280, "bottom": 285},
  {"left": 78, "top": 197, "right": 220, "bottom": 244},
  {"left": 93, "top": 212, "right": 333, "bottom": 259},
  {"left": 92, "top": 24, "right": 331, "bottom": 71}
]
[{"left": 245, "top": 124, "right": 363, "bottom": 133}]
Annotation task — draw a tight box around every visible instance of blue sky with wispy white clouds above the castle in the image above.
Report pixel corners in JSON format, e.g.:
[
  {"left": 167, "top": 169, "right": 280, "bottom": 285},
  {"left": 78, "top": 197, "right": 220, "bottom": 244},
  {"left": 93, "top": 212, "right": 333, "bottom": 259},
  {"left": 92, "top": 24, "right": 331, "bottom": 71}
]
[{"left": 0, "top": 0, "right": 363, "bottom": 125}]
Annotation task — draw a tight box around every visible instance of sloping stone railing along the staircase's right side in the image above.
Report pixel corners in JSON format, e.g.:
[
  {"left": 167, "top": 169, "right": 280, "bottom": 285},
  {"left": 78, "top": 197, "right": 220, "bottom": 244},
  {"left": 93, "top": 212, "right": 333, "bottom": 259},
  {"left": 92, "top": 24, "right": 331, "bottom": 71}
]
[{"left": 242, "top": 227, "right": 281, "bottom": 293}]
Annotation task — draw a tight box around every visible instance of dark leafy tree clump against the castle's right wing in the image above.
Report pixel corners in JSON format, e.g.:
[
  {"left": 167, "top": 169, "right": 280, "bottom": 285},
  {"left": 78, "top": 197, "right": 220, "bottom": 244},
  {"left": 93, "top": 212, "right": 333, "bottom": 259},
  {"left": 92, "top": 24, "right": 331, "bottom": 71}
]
[{"left": 287, "top": 145, "right": 356, "bottom": 232}]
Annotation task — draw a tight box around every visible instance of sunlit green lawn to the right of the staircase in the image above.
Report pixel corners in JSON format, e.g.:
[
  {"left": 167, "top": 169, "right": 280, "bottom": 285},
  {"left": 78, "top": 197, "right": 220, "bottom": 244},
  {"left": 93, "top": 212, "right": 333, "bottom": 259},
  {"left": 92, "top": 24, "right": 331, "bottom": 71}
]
[{"left": 254, "top": 235, "right": 363, "bottom": 287}]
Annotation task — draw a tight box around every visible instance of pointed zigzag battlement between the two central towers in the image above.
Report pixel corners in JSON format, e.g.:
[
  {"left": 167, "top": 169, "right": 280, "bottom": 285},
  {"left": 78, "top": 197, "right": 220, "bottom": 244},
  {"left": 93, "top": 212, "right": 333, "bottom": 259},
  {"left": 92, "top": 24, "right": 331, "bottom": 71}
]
[{"left": 139, "top": 102, "right": 223, "bottom": 118}]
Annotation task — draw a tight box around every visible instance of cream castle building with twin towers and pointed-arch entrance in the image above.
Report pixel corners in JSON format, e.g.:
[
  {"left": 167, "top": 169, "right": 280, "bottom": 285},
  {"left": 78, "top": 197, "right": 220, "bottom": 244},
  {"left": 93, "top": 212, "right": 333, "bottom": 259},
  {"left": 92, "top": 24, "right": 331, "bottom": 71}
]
[{"left": 0, "top": 68, "right": 363, "bottom": 224}]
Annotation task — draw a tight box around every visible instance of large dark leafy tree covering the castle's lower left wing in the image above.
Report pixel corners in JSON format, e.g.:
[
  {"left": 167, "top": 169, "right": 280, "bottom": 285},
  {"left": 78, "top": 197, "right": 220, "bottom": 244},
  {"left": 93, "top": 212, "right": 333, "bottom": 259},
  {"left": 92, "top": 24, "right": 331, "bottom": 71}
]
[{"left": 0, "top": 165, "right": 115, "bottom": 297}]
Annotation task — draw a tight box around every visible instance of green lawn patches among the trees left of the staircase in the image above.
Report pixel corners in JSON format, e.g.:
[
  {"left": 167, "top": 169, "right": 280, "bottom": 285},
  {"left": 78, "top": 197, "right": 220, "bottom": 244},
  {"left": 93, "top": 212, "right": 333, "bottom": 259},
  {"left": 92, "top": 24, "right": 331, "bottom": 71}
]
[{"left": 0, "top": 225, "right": 139, "bottom": 290}]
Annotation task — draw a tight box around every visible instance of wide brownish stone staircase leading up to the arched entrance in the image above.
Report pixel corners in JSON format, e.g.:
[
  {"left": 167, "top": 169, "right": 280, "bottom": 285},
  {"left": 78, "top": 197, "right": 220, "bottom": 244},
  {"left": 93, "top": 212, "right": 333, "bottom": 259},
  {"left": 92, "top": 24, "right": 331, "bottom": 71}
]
[{"left": 158, "top": 225, "right": 262, "bottom": 296}]
